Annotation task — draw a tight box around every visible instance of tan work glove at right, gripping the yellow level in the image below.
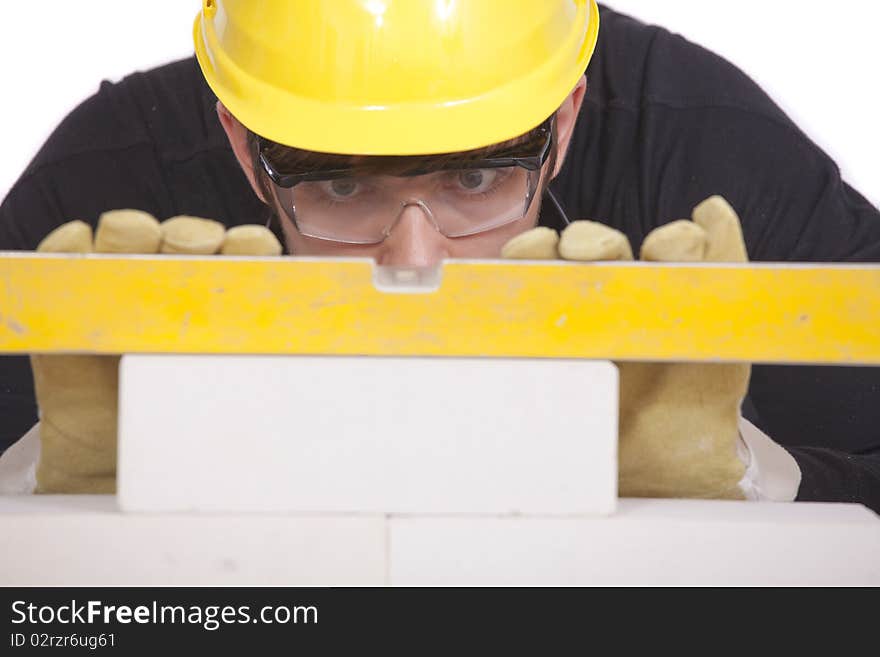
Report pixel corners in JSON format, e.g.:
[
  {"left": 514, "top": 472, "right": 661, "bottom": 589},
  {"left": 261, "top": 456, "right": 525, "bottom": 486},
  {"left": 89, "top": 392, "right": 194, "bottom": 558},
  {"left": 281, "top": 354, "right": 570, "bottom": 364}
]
[{"left": 502, "top": 196, "right": 751, "bottom": 499}]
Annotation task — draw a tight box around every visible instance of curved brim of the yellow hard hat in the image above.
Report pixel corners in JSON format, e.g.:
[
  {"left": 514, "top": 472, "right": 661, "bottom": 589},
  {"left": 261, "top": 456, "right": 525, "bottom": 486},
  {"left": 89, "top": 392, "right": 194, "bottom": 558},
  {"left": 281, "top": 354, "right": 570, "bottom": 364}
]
[{"left": 193, "top": 0, "right": 599, "bottom": 156}]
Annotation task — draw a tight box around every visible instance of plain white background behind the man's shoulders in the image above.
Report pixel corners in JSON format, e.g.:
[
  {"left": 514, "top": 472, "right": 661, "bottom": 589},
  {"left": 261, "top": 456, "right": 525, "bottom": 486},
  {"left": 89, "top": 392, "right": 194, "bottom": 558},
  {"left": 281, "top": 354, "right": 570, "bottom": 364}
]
[{"left": 0, "top": 0, "right": 880, "bottom": 205}]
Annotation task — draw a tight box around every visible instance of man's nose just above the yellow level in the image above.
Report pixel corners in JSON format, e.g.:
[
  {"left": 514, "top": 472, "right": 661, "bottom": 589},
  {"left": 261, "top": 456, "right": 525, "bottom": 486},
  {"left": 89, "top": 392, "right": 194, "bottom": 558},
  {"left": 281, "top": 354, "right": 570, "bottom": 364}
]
[{"left": 376, "top": 203, "right": 450, "bottom": 267}]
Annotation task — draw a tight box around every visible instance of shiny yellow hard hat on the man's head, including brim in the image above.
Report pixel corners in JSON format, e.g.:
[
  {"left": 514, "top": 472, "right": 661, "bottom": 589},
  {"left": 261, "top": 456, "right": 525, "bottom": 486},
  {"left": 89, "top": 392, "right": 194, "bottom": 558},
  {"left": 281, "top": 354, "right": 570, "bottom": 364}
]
[{"left": 194, "top": 0, "right": 599, "bottom": 155}]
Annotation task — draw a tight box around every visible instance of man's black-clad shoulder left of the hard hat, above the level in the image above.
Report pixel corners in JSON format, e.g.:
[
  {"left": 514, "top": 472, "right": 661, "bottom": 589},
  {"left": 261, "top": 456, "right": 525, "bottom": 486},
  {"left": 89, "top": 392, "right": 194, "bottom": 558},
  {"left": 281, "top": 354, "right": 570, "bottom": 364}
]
[{"left": 0, "top": 58, "right": 251, "bottom": 249}]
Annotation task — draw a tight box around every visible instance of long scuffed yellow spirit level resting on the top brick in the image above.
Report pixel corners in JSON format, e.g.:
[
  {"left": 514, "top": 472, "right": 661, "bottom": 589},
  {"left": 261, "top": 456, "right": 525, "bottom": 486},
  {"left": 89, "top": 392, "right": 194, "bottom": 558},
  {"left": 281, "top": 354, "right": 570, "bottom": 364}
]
[{"left": 0, "top": 253, "right": 880, "bottom": 364}]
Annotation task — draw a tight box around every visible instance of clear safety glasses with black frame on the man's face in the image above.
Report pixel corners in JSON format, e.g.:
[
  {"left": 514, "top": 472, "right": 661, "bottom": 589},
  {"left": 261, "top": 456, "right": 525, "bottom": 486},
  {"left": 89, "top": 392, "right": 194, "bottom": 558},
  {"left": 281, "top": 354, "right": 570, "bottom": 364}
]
[{"left": 258, "top": 118, "right": 554, "bottom": 245}]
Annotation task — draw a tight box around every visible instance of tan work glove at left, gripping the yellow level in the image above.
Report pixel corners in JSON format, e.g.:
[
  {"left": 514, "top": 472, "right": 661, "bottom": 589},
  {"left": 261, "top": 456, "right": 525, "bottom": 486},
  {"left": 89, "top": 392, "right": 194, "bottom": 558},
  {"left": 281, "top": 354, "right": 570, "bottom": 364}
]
[{"left": 31, "top": 210, "right": 281, "bottom": 493}]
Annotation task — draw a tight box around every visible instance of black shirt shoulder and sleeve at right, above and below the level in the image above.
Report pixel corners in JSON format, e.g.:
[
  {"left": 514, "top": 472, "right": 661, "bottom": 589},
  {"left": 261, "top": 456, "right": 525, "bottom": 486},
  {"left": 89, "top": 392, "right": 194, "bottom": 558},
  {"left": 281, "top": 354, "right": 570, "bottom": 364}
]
[{"left": 548, "top": 10, "right": 880, "bottom": 511}]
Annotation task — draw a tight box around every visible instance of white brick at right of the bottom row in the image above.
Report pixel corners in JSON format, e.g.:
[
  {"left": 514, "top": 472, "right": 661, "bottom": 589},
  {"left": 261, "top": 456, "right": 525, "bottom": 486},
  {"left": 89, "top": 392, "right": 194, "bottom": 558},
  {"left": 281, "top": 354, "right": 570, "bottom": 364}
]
[{"left": 390, "top": 500, "right": 880, "bottom": 586}]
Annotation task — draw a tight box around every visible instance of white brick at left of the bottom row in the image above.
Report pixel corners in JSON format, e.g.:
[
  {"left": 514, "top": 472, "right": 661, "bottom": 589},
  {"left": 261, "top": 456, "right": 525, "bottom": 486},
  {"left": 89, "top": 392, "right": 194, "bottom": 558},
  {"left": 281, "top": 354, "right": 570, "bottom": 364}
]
[{"left": 0, "top": 496, "right": 387, "bottom": 586}]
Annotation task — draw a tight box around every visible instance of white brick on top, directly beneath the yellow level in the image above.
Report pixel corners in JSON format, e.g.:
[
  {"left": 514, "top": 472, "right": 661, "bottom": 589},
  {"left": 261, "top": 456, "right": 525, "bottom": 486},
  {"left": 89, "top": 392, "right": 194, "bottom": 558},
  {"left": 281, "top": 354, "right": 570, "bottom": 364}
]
[{"left": 119, "top": 356, "right": 617, "bottom": 514}]
